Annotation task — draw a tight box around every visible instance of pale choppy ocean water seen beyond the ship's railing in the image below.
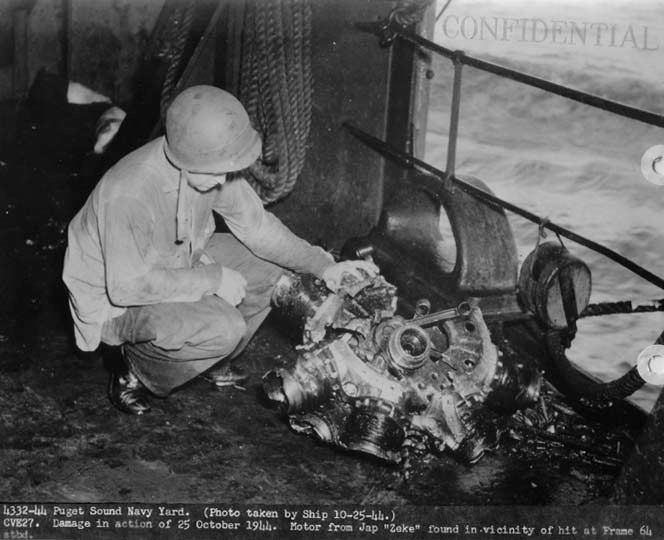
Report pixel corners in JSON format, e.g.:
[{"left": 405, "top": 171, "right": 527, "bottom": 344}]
[{"left": 426, "top": 0, "right": 664, "bottom": 409}]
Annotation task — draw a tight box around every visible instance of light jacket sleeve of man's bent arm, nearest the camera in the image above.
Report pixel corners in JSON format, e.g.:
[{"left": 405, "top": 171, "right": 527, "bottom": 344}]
[{"left": 100, "top": 197, "right": 223, "bottom": 307}]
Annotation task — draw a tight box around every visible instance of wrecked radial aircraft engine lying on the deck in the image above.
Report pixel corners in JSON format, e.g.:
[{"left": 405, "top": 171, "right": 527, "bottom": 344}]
[{"left": 264, "top": 275, "right": 536, "bottom": 462}]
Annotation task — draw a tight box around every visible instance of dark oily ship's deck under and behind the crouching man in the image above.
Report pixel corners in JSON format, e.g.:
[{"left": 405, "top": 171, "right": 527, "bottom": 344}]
[{"left": 0, "top": 132, "right": 617, "bottom": 505}]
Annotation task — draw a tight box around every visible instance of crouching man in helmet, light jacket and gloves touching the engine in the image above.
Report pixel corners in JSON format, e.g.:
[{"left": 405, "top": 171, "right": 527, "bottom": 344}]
[{"left": 63, "top": 86, "right": 377, "bottom": 414}]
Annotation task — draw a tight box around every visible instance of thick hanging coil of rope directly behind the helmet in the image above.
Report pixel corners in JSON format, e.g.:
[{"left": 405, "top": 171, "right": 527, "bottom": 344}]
[{"left": 239, "top": 0, "right": 313, "bottom": 204}]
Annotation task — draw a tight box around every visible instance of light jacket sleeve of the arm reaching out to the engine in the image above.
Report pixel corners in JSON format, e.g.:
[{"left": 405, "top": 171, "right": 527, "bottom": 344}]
[{"left": 214, "top": 178, "right": 334, "bottom": 277}]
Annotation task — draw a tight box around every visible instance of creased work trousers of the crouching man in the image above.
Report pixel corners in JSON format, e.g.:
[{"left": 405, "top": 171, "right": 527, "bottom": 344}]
[{"left": 102, "top": 233, "right": 283, "bottom": 397}]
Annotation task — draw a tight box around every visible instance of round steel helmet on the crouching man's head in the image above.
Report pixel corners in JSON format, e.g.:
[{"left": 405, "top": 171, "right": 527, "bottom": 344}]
[{"left": 165, "top": 85, "right": 261, "bottom": 174}]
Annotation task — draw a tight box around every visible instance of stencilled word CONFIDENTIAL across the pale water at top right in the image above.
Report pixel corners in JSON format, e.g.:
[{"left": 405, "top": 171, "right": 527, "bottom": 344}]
[{"left": 442, "top": 15, "right": 659, "bottom": 51}]
